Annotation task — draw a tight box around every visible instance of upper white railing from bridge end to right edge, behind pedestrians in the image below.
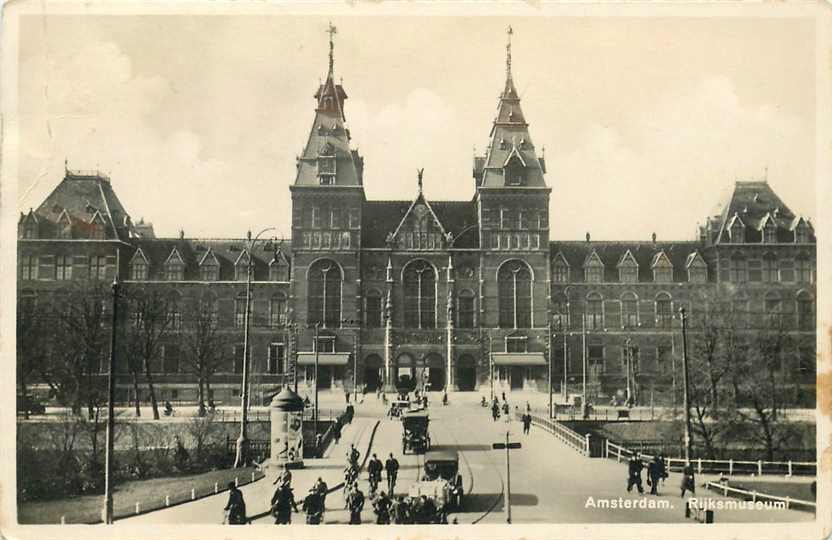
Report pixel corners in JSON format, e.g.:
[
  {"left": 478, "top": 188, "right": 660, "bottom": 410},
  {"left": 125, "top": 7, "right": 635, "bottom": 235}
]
[{"left": 604, "top": 439, "right": 817, "bottom": 476}]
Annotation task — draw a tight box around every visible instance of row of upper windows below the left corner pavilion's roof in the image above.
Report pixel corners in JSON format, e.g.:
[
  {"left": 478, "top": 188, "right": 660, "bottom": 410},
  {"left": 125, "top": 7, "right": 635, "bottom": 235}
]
[{"left": 19, "top": 255, "right": 116, "bottom": 281}]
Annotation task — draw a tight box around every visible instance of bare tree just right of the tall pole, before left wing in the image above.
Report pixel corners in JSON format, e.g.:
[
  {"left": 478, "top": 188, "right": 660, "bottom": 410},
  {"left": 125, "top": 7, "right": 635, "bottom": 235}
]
[{"left": 125, "top": 289, "right": 171, "bottom": 420}]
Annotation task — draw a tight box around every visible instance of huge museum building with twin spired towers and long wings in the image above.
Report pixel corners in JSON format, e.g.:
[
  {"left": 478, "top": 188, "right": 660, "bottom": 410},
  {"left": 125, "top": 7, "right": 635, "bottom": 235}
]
[{"left": 18, "top": 35, "right": 815, "bottom": 408}]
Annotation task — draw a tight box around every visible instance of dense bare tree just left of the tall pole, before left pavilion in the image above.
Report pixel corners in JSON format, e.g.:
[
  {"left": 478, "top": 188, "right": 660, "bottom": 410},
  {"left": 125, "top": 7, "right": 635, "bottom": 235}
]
[{"left": 43, "top": 282, "right": 111, "bottom": 419}]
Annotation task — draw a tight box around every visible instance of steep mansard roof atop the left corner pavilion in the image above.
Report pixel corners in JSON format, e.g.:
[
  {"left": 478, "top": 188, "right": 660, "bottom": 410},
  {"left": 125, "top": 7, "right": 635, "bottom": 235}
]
[{"left": 30, "top": 170, "right": 138, "bottom": 240}]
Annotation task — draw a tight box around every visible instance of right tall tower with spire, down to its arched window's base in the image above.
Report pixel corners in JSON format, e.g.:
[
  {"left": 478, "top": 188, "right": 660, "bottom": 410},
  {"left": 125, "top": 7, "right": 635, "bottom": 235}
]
[{"left": 473, "top": 27, "right": 551, "bottom": 328}]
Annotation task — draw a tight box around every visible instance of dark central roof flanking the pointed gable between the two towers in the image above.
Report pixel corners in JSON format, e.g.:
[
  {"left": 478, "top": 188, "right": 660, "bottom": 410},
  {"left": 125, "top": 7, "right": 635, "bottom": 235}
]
[{"left": 361, "top": 201, "right": 479, "bottom": 248}]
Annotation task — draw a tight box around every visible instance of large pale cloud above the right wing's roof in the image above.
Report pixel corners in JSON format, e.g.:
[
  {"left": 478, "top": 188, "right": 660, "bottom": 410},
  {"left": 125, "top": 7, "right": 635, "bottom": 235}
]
[{"left": 547, "top": 77, "right": 812, "bottom": 240}]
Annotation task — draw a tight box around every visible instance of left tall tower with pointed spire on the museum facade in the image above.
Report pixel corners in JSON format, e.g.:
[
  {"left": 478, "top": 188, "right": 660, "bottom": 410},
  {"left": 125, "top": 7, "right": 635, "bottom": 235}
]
[{"left": 290, "top": 23, "right": 365, "bottom": 384}]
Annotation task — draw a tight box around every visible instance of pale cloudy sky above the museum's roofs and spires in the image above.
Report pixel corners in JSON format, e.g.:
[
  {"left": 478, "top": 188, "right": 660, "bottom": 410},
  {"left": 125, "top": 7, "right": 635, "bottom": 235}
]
[{"left": 17, "top": 15, "right": 816, "bottom": 240}]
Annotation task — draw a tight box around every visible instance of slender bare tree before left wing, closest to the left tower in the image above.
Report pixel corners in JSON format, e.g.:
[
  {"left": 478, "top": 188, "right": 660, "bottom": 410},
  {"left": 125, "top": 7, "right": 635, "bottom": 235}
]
[{"left": 183, "top": 295, "right": 228, "bottom": 416}]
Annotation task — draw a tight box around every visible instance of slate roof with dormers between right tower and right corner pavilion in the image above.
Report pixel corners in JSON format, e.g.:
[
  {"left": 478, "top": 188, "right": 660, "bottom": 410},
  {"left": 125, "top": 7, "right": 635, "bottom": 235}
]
[{"left": 549, "top": 241, "right": 702, "bottom": 282}]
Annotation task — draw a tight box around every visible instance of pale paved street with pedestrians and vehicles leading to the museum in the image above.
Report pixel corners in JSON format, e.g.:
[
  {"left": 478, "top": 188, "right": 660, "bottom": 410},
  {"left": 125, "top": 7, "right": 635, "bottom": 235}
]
[{"left": 117, "top": 394, "right": 814, "bottom": 524}]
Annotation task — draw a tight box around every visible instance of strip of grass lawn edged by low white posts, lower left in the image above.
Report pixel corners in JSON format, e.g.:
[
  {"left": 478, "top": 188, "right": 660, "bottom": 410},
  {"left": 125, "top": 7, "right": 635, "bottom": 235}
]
[{"left": 17, "top": 467, "right": 263, "bottom": 524}]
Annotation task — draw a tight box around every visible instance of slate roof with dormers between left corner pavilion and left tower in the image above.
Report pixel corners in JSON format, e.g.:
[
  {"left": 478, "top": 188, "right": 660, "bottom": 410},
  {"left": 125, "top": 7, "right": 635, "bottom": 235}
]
[{"left": 124, "top": 238, "right": 291, "bottom": 281}]
